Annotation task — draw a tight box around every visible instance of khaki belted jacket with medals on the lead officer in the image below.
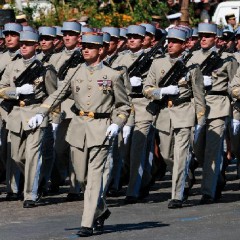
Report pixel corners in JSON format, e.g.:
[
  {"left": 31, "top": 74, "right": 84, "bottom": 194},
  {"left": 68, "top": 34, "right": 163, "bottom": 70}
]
[{"left": 39, "top": 62, "right": 130, "bottom": 148}]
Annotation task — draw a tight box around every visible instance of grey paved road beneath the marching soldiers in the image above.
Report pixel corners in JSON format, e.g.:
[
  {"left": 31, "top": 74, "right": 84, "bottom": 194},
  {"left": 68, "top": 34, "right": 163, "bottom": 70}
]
[{"left": 0, "top": 161, "right": 240, "bottom": 240}]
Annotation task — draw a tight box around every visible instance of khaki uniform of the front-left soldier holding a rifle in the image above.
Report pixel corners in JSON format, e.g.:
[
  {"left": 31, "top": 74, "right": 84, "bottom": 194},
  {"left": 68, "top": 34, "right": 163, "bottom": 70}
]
[{"left": 0, "top": 56, "right": 57, "bottom": 200}]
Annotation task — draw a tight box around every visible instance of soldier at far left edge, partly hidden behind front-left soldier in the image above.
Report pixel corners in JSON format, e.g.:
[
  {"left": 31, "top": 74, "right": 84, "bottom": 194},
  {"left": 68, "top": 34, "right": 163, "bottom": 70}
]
[{"left": 0, "top": 23, "right": 23, "bottom": 201}]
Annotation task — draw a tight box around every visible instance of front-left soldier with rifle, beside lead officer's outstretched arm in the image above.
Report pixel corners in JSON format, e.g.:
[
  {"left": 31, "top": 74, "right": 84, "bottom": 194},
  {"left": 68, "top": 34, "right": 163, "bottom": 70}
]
[{"left": 0, "top": 31, "right": 57, "bottom": 208}]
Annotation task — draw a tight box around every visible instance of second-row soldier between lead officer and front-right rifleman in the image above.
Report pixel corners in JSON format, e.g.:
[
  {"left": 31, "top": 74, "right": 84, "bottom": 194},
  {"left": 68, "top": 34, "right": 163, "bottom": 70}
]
[{"left": 113, "top": 25, "right": 153, "bottom": 204}]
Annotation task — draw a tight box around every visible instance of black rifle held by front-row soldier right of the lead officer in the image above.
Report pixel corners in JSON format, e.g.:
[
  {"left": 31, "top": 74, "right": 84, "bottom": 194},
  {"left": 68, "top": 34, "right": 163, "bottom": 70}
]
[{"left": 146, "top": 43, "right": 198, "bottom": 116}]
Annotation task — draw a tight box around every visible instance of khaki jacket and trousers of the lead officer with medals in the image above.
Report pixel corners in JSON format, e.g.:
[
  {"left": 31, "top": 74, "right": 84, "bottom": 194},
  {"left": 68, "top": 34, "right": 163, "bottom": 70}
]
[{"left": 40, "top": 62, "right": 130, "bottom": 228}]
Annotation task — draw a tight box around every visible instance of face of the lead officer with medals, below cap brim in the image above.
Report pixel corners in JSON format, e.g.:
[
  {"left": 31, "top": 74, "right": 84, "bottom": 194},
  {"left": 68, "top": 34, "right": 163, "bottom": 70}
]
[{"left": 82, "top": 43, "right": 103, "bottom": 63}]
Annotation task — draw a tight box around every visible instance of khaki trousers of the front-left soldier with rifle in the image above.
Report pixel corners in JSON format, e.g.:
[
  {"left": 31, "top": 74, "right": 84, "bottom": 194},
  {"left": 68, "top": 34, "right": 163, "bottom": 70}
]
[{"left": 10, "top": 128, "right": 44, "bottom": 201}]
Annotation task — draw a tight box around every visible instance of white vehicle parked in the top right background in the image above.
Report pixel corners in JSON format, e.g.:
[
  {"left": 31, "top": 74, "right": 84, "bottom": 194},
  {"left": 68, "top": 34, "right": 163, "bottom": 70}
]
[{"left": 212, "top": 1, "right": 240, "bottom": 25}]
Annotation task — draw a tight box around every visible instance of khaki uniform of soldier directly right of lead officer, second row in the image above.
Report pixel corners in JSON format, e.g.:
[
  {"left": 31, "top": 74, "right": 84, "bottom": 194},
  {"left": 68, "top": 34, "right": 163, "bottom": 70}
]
[{"left": 112, "top": 51, "right": 153, "bottom": 198}]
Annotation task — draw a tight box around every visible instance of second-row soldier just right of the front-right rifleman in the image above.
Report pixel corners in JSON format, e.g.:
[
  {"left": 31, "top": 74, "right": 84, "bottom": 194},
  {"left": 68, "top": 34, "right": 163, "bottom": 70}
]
[{"left": 191, "top": 23, "right": 237, "bottom": 204}]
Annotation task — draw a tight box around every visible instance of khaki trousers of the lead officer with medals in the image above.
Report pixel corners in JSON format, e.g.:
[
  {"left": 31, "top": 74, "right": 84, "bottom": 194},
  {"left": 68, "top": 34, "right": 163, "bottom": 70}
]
[{"left": 70, "top": 143, "right": 109, "bottom": 228}]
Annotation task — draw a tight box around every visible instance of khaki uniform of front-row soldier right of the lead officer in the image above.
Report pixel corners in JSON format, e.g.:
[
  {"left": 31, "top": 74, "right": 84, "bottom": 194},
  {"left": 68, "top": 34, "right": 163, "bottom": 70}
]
[{"left": 143, "top": 56, "right": 205, "bottom": 200}]
